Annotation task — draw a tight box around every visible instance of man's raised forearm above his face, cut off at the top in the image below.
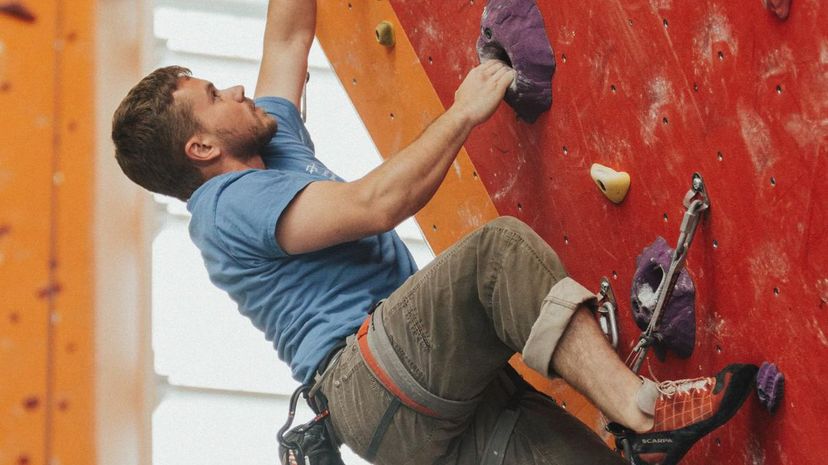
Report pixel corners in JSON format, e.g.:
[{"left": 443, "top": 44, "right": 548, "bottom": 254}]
[{"left": 255, "top": 0, "right": 316, "bottom": 108}]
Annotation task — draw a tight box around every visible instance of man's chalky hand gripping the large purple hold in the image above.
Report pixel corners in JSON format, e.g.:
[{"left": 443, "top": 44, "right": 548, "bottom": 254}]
[{"left": 450, "top": 60, "right": 515, "bottom": 126}]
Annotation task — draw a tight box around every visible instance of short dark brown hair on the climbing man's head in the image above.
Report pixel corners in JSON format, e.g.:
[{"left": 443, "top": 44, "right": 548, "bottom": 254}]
[{"left": 112, "top": 66, "right": 204, "bottom": 201}]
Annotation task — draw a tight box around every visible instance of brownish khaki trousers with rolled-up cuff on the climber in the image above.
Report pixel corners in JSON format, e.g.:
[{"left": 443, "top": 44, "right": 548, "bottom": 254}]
[{"left": 320, "top": 218, "right": 625, "bottom": 465}]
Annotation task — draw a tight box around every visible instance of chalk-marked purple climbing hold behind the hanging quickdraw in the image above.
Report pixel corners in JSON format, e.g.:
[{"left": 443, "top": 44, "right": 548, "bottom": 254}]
[{"left": 630, "top": 236, "right": 696, "bottom": 359}]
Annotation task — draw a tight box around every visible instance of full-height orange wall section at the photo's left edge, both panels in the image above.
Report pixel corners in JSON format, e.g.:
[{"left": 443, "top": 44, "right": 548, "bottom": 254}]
[{"left": 0, "top": 0, "right": 95, "bottom": 465}]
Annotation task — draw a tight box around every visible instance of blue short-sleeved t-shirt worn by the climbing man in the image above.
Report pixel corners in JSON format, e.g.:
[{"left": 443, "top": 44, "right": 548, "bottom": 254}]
[{"left": 187, "top": 97, "right": 417, "bottom": 382}]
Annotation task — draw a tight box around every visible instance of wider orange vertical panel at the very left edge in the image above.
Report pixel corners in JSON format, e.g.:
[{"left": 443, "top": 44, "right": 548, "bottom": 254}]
[{"left": 0, "top": 2, "right": 56, "bottom": 465}]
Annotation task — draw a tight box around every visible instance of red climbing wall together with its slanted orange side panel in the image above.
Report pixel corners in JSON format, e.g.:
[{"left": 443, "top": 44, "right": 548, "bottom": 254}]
[{"left": 318, "top": 0, "right": 828, "bottom": 465}]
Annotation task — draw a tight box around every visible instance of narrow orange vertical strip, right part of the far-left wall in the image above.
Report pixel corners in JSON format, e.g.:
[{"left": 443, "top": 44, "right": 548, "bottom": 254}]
[{"left": 49, "top": 0, "right": 96, "bottom": 464}]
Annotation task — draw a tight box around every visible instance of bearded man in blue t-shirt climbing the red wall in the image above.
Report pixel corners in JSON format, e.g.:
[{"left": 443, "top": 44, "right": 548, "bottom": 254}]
[{"left": 112, "top": 0, "right": 756, "bottom": 464}]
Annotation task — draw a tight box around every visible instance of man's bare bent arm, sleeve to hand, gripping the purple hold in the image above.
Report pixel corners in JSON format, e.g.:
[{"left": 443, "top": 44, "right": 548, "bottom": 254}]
[{"left": 276, "top": 61, "right": 514, "bottom": 254}]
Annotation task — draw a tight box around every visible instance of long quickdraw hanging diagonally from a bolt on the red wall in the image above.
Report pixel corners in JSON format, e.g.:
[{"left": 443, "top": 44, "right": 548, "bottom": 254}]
[{"left": 628, "top": 173, "right": 710, "bottom": 373}]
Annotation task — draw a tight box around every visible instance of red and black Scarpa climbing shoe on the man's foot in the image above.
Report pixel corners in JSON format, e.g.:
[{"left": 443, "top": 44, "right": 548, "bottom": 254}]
[{"left": 607, "top": 364, "right": 758, "bottom": 465}]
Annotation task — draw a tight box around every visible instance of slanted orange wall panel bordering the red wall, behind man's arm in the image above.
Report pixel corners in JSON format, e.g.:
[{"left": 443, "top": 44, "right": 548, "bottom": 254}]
[{"left": 317, "top": 0, "right": 497, "bottom": 253}]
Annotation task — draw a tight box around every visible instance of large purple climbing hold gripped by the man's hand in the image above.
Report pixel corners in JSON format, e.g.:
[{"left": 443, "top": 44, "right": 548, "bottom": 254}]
[{"left": 477, "top": 0, "right": 555, "bottom": 123}]
